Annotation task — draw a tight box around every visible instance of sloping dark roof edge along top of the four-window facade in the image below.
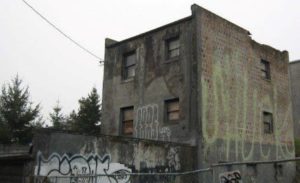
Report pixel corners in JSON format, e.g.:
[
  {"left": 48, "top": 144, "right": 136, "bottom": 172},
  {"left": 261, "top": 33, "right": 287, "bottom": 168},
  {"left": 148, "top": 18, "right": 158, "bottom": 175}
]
[{"left": 106, "top": 15, "right": 193, "bottom": 48}]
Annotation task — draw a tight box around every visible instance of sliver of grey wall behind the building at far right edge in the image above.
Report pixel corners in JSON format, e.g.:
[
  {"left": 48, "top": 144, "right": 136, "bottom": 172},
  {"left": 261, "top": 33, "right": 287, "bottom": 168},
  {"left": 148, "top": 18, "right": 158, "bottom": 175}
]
[{"left": 289, "top": 60, "right": 300, "bottom": 147}]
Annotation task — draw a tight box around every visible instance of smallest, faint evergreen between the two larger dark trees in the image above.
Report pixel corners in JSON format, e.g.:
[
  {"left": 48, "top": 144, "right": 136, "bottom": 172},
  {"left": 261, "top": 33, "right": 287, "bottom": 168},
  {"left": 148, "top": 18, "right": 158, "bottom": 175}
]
[{"left": 49, "top": 101, "right": 66, "bottom": 129}]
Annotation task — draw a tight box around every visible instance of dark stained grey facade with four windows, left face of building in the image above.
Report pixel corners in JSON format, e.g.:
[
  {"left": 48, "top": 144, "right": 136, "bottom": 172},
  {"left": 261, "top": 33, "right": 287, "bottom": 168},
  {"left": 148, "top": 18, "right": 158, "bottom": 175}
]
[{"left": 102, "top": 17, "right": 196, "bottom": 143}]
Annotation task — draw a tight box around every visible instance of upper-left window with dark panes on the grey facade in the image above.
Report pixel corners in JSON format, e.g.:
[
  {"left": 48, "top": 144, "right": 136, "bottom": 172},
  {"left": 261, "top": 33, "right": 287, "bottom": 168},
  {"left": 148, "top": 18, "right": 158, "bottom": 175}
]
[{"left": 123, "top": 52, "right": 136, "bottom": 79}]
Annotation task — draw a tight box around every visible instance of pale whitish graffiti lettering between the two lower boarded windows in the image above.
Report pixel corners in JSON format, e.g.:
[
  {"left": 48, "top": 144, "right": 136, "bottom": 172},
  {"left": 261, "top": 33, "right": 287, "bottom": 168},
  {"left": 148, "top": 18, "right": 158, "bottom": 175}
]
[{"left": 135, "top": 104, "right": 171, "bottom": 141}]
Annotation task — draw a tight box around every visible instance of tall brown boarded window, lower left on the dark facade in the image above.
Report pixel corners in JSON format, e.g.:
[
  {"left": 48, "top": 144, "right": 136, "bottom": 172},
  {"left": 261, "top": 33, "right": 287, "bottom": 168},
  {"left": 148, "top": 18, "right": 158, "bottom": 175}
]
[{"left": 121, "top": 106, "right": 134, "bottom": 135}]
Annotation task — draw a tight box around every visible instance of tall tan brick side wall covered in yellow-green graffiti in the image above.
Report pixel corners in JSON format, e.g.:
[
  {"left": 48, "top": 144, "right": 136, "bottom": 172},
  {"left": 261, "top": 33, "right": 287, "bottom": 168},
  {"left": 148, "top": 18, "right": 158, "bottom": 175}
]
[{"left": 192, "top": 3, "right": 294, "bottom": 182}]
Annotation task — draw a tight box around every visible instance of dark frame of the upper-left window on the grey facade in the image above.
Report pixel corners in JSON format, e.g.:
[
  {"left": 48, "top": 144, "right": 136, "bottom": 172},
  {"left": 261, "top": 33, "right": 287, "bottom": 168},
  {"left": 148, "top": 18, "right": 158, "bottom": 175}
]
[{"left": 122, "top": 50, "right": 137, "bottom": 80}]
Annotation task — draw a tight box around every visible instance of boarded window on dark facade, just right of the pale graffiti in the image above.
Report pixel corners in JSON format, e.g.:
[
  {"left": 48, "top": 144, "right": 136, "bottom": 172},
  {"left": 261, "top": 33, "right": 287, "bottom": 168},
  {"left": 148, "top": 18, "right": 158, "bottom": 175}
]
[{"left": 165, "top": 98, "right": 180, "bottom": 121}]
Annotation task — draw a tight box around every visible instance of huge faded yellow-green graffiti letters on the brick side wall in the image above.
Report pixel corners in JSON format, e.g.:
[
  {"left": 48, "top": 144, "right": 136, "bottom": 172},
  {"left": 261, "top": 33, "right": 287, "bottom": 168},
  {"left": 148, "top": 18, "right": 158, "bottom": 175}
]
[{"left": 201, "top": 50, "right": 294, "bottom": 160}]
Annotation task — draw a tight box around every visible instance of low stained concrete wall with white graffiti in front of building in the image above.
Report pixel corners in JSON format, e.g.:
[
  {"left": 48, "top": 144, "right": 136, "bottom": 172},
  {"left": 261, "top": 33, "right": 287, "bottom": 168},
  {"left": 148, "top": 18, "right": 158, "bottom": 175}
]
[{"left": 31, "top": 131, "right": 195, "bottom": 183}]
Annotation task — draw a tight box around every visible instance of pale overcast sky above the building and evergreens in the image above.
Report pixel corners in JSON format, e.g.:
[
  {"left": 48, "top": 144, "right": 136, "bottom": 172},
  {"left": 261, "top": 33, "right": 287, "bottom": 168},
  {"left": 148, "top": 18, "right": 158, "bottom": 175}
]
[{"left": 0, "top": 0, "right": 300, "bottom": 124}]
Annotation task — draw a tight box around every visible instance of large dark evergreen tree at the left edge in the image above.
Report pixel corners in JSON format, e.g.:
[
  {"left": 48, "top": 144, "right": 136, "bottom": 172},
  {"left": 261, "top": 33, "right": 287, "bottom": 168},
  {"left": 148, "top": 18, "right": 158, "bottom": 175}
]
[{"left": 0, "top": 76, "right": 41, "bottom": 143}]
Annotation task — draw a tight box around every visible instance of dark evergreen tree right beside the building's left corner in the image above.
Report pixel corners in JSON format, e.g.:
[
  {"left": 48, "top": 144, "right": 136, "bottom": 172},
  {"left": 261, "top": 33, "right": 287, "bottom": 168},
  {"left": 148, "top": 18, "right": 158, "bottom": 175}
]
[{"left": 70, "top": 88, "right": 101, "bottom": 134}]
